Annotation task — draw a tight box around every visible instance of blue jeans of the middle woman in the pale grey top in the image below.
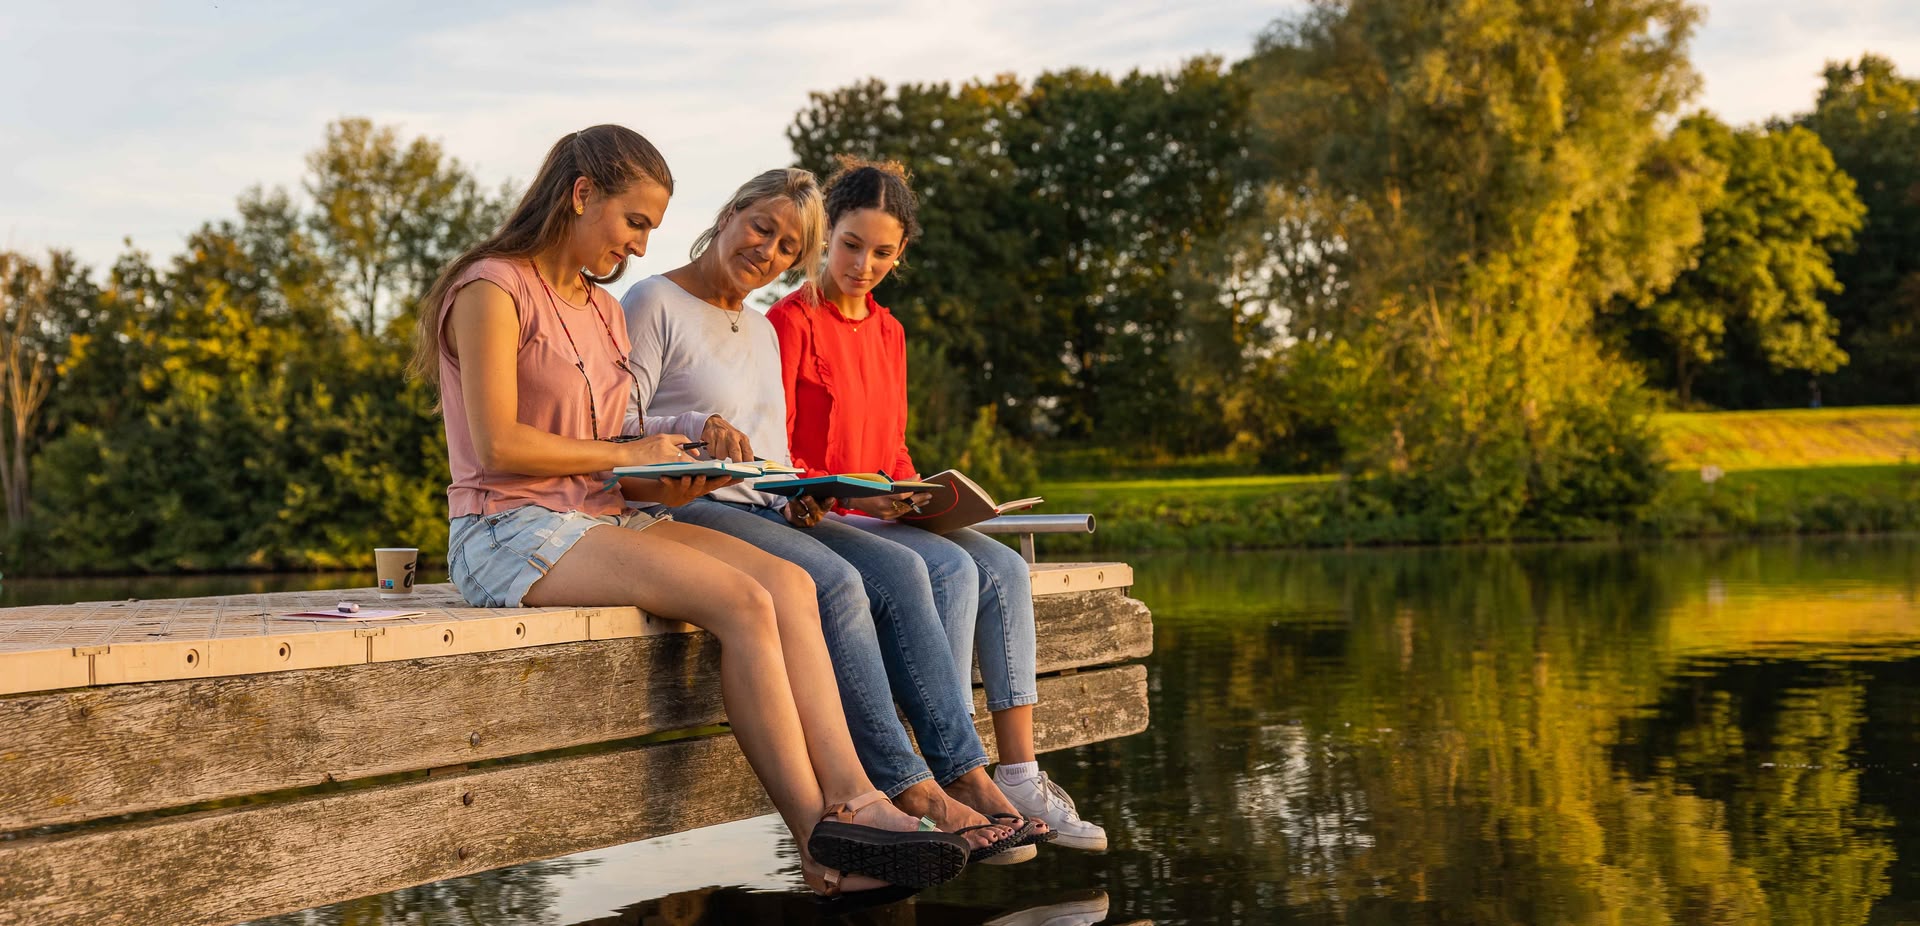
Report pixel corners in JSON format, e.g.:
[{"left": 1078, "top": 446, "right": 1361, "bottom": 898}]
[{"left": 672, "top": 498, "right": 987, "bottom": 797}]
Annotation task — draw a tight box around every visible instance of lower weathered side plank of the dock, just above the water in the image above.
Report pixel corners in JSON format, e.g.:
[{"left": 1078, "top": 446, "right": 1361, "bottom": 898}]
[{"left": 0, "top": 665, "right": 1146, "bottom": 926}]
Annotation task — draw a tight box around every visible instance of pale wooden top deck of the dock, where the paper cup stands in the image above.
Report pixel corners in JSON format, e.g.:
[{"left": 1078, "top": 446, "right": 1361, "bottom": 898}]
[{"left": 0, "top": 563, "right": 1133, "bottom": 694}]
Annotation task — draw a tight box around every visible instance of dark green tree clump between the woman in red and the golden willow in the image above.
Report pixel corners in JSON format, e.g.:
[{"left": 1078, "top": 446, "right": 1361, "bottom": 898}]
[{"left": 787, "top": 58, "right": 1252, "bottom": 442}]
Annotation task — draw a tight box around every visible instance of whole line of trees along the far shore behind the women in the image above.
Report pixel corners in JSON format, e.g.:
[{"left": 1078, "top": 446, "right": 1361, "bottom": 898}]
[{"left": 0, "top": 0, "right": 1920, "bottom": 571}]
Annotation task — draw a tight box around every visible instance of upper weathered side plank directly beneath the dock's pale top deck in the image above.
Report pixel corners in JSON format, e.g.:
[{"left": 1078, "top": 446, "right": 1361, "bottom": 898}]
[{"left": 0, "top": 590, "right": 1152, "bottom": 832}]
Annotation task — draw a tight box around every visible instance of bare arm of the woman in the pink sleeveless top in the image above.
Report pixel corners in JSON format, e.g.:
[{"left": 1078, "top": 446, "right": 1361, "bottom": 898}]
[{"left": 447, "top": 280, "right": 689, "bottom": 476}]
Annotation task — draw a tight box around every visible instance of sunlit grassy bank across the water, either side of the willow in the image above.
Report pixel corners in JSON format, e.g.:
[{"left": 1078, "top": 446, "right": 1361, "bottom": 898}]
[{"left": 1039, "top": 407, "right": 1920, "bottom": 555}]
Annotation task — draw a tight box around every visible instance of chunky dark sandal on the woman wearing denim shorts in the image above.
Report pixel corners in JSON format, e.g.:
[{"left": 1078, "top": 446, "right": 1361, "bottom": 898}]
[{"left": 806, "top": 790, "right": 968, "bottom": 893}]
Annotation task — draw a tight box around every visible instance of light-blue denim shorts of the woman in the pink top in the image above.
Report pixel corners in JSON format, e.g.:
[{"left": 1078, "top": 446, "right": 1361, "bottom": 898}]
[{"left": 447, "top": 505, "right": 672, "bottom": 607}]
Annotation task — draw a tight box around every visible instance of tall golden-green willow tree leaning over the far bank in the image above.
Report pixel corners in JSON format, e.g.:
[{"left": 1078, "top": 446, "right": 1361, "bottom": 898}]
[{"left": 1252, "top": 0, "right": 1699, "bottom": 536}]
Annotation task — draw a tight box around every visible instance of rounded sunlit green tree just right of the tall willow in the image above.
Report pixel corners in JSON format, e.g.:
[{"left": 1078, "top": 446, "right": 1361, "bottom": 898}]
[{"left": 1645, "top": 113, "right": 1864, "bottom": 405}]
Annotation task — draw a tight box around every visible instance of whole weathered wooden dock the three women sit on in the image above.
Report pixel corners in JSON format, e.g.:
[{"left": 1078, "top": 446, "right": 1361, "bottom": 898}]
[{"left": 0, "top": 563, "right": 1152, "bottom": 926}]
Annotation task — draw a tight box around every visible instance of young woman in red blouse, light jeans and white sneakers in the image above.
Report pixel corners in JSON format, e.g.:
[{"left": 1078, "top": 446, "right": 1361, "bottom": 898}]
[{"left": 768, "top": 159, "right": 1106, "bottom": 851}]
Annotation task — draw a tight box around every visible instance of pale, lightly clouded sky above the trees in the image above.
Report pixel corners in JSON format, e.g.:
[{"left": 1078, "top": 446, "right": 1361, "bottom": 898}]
[{"left": 0, "top": 0, "right": 1920, "bottom": 290}]
